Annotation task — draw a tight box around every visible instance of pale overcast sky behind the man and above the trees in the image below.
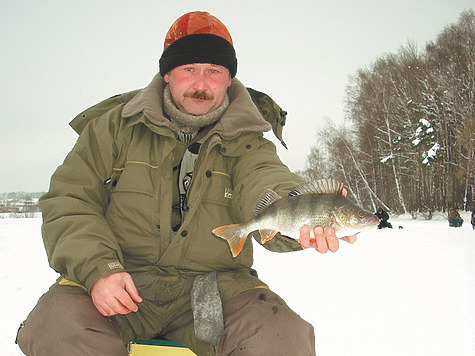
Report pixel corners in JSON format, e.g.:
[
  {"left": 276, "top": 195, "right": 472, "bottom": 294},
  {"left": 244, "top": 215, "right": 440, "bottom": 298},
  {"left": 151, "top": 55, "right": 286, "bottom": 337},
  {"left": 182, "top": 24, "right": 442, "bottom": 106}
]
[{"left": 0, "top": 0, "right": 473, "bottom": 192}]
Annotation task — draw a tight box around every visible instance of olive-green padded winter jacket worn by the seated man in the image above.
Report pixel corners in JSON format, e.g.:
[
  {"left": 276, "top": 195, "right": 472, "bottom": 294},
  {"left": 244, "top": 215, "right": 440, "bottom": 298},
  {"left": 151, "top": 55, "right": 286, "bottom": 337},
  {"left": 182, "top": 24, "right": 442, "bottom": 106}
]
[{"left": 40, "top": 75, "right": 301, "bottom": 302}]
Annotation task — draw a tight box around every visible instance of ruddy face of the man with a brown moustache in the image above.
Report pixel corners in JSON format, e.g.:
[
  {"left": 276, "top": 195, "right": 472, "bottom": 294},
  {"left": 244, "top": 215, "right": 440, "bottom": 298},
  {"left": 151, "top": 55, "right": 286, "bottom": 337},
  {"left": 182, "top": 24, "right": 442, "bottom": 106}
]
[{"left": 164, "top": 63, "right": 231, "bottom": 115}]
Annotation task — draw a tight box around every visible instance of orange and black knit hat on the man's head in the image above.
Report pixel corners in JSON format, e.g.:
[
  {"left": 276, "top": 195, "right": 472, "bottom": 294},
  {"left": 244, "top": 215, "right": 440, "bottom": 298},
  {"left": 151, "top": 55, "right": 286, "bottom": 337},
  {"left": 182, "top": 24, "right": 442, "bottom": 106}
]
[{"left": 159, "top": 11, "right": 237, "bottom": 78}]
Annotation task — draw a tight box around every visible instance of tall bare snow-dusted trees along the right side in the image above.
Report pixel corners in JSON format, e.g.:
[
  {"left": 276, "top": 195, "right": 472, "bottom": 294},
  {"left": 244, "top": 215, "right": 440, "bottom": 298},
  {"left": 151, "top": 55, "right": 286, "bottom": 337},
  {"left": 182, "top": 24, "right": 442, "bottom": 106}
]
[{"left": 300, "top": 10, "right": 475, "bottom": 216}]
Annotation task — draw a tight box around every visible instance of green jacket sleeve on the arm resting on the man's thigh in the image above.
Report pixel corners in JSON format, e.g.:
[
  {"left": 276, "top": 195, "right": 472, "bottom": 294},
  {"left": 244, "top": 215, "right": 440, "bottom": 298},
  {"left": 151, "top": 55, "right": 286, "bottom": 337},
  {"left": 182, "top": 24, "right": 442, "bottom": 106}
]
[{"left": 40, "top": 110, "right": 123, "bottom": 291}]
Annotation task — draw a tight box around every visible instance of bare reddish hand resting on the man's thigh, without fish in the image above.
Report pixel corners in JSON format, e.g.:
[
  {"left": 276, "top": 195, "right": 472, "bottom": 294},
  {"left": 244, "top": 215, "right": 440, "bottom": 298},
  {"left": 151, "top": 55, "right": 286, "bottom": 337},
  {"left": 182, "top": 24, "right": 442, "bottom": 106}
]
[{"left": 91, "top": 272, "right": 142, "bottom": 316}]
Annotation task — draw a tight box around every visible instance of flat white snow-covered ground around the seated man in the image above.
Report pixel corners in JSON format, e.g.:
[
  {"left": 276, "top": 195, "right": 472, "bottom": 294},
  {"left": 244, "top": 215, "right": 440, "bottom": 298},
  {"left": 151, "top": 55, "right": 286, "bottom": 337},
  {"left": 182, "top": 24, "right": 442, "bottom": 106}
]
[{"left": 0, "top": 213, "right": 475, "bottom": 356}]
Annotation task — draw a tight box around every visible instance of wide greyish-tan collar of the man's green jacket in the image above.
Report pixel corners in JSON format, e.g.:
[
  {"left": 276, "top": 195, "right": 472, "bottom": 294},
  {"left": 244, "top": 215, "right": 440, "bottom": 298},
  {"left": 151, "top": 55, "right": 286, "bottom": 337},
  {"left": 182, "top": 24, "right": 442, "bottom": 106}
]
[{"left": 122, "top": 74, "right": 272, "bottom": 139}]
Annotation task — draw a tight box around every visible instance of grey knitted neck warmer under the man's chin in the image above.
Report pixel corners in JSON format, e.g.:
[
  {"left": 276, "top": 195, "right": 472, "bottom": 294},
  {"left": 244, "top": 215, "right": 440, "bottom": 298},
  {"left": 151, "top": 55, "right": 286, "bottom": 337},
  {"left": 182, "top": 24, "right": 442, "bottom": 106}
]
[{"left": 163, "top": 85, "right": 229, "bottom": 142}]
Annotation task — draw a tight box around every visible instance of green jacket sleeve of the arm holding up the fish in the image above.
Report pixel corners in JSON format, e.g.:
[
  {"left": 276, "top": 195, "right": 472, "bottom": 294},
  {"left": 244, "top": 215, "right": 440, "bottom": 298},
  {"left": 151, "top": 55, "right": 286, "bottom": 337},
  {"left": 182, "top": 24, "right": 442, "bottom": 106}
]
[{"left": 233, "top": 136, "right": 303, "bottom": 252}]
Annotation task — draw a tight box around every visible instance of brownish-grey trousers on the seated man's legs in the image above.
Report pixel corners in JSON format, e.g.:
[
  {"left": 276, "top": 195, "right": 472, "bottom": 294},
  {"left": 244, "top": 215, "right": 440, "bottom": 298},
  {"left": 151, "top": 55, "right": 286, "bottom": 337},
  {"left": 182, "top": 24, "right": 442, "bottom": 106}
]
[{"left": 18, "top": 284, "right": 315, "bottom": 356}]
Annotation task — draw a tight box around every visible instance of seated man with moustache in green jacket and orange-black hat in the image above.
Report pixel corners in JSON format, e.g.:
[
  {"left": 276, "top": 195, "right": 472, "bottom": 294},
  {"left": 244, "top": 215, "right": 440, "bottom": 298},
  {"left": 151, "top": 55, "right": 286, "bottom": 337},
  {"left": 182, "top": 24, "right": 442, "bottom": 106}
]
[{"left": 18, "top": 12, "right": 355, "bottom": 356}]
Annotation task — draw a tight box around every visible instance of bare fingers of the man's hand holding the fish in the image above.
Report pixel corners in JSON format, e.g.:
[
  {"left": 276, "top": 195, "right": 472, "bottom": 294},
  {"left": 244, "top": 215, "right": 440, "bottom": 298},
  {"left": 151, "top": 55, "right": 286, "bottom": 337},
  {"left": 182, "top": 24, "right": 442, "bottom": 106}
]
[{"left": 299, "top": 225, "right": 356, "bottom": 253}]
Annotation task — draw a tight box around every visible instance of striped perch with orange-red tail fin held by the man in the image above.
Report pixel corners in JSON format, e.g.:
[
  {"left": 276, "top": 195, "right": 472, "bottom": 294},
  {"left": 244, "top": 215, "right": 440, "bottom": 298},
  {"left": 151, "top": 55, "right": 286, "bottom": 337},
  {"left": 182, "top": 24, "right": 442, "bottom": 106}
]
[{"left": 213, "top": 179, "right": 379, "bottom": 257}]
